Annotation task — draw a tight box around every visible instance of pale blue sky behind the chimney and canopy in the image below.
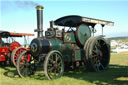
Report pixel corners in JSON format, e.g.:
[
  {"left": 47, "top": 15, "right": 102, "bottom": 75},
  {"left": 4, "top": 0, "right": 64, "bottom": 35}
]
[{"left": 0, "top": 0, "right": 128, "bottom": 43}]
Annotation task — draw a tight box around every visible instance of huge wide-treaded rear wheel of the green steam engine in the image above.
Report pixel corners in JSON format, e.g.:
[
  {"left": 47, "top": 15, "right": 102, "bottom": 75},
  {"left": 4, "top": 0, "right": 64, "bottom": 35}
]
[{"left": 84, "top": 37, "right": 110, "bottom": 72}]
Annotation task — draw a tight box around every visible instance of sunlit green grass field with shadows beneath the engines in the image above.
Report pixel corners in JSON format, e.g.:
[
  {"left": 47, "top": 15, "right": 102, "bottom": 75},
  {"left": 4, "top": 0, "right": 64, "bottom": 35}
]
[{"left": 0, "top": 53, "right": 128, "bottom": 85}]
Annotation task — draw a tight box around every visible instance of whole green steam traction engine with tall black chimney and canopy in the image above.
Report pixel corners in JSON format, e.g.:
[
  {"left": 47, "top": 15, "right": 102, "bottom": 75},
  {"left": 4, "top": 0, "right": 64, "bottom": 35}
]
[{"left": 17, "top": 6, "right": 114, "bottom": 79}]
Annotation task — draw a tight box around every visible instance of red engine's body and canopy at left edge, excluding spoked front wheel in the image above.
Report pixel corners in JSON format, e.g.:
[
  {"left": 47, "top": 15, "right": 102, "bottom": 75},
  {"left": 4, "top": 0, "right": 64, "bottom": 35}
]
[{"left": 0, "top": 30, "right": 34, "bottom": 65}]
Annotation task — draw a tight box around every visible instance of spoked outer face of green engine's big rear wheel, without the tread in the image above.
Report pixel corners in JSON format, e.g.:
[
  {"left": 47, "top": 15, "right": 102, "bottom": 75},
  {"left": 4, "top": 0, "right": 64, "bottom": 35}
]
[{"left": 90, "top": 39, "right": 109, "bottom": 72}]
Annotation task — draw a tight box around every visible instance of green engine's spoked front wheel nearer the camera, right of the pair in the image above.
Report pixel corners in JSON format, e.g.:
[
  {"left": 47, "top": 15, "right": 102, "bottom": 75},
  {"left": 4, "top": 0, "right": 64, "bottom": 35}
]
[{"left": 44, "top": 50, "right": 64, "bottom": 80}]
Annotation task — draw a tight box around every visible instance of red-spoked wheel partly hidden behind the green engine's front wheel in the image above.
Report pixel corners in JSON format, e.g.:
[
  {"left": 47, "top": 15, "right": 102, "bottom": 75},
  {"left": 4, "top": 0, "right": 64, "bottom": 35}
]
[{"left": 11, "top": 47, "right": 30, "bottom": 66}]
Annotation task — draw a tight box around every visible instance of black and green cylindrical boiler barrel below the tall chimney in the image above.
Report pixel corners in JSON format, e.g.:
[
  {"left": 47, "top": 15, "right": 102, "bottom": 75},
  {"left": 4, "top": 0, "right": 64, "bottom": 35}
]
[{"left": 30, "top": 38, "right": 63, "bottom": 56}]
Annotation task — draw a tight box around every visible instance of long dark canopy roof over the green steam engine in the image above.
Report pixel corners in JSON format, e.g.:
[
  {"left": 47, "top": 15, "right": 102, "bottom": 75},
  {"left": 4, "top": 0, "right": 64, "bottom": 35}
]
[{"left": 54, "top": 15, "right": 114, "bottom": 27}]
